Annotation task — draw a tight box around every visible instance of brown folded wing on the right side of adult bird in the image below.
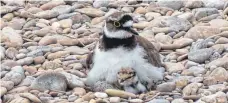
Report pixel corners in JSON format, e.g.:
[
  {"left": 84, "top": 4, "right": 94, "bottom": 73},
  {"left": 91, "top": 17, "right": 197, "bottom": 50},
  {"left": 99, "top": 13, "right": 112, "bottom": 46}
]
[{"left": 135, "top": 35, "right": 162, "bottom": 67}]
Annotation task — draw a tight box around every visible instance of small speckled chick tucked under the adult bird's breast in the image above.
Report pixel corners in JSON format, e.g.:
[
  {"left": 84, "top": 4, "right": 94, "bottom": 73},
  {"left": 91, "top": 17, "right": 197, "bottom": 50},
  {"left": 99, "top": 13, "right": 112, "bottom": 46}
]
[{"left": 117, "top": 67, "right": 147, "bottom": 94}]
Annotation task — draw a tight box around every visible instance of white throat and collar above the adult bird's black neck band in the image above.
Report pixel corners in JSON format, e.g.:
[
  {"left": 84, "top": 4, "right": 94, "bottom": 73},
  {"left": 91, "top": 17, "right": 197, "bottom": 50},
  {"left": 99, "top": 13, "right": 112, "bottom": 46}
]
[{"left": 104, "top": 23, "right": 133, "bottom": 38}]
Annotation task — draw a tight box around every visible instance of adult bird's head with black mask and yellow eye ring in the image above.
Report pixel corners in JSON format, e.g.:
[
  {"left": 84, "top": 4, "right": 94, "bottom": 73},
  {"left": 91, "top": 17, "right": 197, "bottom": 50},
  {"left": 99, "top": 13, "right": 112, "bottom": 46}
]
[{"left": 104, "top": 12, "right": 136, "bottom": 38}]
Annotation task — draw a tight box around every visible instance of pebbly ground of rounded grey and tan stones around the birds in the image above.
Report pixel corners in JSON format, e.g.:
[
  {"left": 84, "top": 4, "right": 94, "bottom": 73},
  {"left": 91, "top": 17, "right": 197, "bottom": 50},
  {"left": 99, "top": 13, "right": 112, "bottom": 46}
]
[{"left": 0, "top": 0, "right": 228, "bottom": 103}]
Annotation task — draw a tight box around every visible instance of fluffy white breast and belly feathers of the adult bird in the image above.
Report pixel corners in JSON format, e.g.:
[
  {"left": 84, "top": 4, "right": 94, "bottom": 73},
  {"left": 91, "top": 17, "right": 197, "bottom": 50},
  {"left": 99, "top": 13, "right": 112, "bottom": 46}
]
[{"left": 87, "top": 45, "right": 163, "bottom": 85}]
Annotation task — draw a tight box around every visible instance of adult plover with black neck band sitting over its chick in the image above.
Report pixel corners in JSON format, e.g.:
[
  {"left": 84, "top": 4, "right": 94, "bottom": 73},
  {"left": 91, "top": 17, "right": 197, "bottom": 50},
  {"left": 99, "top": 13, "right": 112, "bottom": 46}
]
[{"left": 85, "top": 11, "right": 164, "bottom": 88}]
